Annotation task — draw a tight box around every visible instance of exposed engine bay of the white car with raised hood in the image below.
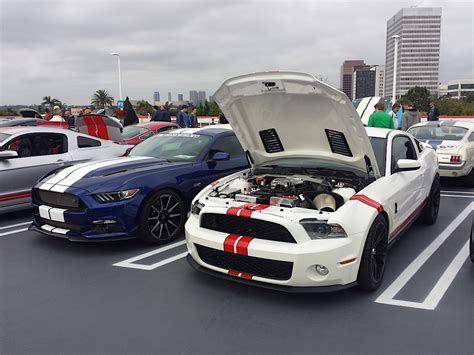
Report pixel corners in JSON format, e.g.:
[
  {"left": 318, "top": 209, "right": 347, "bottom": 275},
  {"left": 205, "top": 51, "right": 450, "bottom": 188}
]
[{"left": 209, "top": 173, "right": 364, "bottom": 212}]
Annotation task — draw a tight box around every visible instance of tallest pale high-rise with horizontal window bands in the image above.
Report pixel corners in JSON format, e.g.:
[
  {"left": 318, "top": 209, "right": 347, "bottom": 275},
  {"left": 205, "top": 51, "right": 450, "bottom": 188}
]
[{"left": 384, "top": 7, "right": 441, "bottom": 97}]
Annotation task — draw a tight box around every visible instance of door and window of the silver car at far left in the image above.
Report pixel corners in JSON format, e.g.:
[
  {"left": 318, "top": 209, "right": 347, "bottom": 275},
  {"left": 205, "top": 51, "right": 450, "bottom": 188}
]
[{"left": 0, "top": 133, "right": 71, "bottom": 205}]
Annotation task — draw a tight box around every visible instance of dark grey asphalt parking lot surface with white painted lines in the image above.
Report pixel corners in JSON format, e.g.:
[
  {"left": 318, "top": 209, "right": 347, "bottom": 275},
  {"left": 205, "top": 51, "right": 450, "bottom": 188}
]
[{"left": 0, "top": 181, "right": 474, "bottom": 354}]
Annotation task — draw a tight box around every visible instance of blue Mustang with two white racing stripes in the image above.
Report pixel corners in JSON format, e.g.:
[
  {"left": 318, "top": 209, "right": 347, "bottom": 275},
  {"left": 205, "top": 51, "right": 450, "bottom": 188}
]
[{"left": 30, "top": 125, "right": 248, "bottom": 244}]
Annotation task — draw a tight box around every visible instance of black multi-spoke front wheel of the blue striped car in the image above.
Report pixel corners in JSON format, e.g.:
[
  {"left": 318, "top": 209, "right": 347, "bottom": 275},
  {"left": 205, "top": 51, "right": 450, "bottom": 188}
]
[{"left": 138, "top": 190, "right": 186, "bottom": 244}]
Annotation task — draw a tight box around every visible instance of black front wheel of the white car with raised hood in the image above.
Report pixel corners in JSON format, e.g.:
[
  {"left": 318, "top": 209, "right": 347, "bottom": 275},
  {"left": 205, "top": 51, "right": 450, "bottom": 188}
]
[{"left": 357, "top": 215, "right": 388, "bottom": 291}]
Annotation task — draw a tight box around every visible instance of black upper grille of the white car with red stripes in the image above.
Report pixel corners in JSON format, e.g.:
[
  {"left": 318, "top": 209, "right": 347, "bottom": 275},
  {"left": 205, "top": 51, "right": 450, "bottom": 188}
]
[{"left": 201, "top": 213, "right": 296, "bottom": 243}]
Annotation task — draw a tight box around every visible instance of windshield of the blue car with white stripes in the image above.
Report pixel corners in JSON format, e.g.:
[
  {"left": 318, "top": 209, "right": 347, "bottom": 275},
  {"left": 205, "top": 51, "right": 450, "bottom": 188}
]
[{"left": 130, "top": 133, "right": 211, "bottom": 162}]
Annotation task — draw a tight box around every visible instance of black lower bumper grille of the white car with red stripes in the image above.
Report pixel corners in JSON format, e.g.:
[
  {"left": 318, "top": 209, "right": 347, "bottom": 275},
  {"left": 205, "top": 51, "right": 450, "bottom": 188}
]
[{"left": 196, "top": 244, "right": 293, "bottom": 280}]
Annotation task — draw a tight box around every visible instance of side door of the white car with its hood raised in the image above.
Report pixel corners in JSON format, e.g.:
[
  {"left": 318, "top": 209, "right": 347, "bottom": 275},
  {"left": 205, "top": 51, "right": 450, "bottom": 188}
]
[{"left": 385, "top": 133, "right": 424, "bottom": 228}]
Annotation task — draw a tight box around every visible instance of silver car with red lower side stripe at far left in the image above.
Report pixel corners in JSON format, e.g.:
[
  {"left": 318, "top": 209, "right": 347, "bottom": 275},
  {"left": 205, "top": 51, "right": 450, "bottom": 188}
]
[{"left": 0, "top": 127, "right": 130, "bottom": 213}]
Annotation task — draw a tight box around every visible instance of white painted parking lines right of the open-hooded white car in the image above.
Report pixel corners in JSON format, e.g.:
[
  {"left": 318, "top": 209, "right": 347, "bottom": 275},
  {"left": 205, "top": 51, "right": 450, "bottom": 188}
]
[{"left": 374, "top": 202, "right": 474, "bottom": 310}]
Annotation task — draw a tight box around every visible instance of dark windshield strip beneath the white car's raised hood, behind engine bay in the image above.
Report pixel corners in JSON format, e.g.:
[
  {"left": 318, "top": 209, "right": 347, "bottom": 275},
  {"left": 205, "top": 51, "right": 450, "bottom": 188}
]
[{"left": 255, "top": 158, "right": 367, "bottom": 177}]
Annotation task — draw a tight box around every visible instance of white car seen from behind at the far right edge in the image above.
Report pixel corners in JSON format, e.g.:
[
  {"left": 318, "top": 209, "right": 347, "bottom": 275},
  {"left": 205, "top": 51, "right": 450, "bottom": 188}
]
[{"left": 408, "top": 120, "right": 474, "bottom": 183}]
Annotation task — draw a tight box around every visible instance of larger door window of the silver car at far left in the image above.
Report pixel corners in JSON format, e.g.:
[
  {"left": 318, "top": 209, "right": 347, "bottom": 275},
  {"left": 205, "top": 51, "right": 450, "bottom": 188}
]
[{"left": 6, "top": 133, "right": 67, "bottom": 158}]
